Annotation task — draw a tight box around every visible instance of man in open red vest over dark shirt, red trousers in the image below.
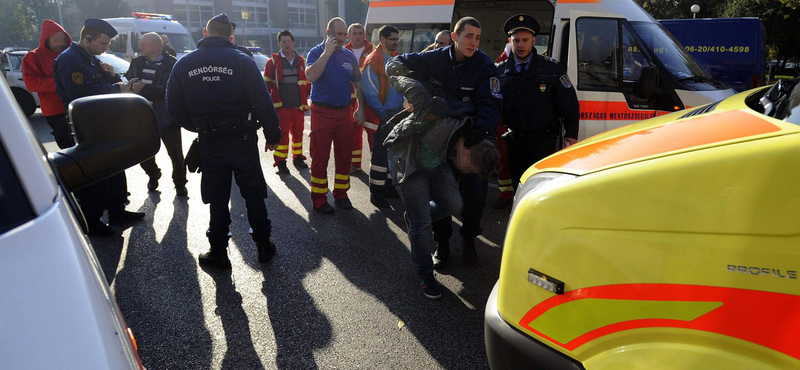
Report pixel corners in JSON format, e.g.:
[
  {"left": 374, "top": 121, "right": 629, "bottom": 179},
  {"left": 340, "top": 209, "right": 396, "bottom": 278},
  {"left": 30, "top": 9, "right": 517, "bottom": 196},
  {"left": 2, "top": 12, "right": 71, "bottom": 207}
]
[{"left": 264, "top": 30, "right": 311, "bottom": 173}]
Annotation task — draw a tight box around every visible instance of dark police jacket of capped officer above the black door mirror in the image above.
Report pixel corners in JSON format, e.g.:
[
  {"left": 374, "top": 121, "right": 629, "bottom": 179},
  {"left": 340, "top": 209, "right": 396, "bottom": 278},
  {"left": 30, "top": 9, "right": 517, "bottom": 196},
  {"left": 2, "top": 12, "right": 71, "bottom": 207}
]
[{"left": 53, "top": 42, "right": 122, "bottom": 107}]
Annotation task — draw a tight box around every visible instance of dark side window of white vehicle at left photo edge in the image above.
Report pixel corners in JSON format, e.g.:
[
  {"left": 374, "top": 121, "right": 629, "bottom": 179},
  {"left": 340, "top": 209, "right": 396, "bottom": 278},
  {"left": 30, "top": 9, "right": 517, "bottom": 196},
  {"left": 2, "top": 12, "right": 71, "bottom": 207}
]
[{"left": 0, "top": 142, "right": 34, "bottom": 234}]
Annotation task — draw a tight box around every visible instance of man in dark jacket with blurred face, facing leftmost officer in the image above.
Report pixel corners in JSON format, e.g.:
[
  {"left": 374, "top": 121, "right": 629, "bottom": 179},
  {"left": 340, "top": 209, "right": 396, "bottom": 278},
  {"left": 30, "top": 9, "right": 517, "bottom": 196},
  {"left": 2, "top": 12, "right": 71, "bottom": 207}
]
[{"left": 125, "top": 32, "right": 187, "bottom": 196}]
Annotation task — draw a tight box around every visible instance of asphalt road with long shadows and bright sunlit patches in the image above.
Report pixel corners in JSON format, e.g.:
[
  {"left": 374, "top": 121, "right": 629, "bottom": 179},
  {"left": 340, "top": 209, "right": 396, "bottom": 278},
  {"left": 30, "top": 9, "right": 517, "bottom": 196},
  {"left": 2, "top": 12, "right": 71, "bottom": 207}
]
[{"left": 31, "top": 112, "right": 508, "bottom": 370}]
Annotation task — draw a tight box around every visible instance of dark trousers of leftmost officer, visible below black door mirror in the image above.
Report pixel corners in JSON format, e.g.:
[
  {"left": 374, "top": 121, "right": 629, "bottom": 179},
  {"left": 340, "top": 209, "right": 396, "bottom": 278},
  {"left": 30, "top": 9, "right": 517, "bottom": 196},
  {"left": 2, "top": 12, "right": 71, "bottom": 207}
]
[{"left": 78, "top": 171, "right": 128, "bottom": 223}]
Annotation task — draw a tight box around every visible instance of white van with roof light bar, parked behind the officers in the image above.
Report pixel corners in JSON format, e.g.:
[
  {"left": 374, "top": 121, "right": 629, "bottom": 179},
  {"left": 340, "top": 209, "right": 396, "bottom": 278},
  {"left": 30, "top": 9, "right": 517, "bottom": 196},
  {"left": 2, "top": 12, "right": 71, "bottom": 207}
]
[{"left": 103, "top": 12, "right": 197, "bottom": 61}]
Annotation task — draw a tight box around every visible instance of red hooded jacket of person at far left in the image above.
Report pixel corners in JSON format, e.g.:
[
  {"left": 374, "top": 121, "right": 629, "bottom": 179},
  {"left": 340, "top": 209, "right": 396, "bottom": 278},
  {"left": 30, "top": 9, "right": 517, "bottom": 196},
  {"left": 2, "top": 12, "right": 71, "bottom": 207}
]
[{"left": 22, "top": 19, "right": 72, "bottom": 117}]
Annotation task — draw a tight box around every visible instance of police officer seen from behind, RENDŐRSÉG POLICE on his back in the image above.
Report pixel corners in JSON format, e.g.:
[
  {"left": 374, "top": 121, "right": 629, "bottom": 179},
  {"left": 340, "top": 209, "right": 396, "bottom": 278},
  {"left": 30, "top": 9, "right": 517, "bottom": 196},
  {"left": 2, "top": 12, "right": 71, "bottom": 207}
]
[{"left": 167, "top": 13, "right": 281, "bottom": 268}]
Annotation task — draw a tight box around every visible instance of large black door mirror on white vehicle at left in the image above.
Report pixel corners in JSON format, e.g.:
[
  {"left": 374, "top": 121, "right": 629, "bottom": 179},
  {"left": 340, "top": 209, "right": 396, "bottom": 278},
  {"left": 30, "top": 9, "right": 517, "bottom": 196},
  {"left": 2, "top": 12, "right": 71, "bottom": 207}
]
[{"left": 48, "top": 94, "right": 161, "bottom": 191}]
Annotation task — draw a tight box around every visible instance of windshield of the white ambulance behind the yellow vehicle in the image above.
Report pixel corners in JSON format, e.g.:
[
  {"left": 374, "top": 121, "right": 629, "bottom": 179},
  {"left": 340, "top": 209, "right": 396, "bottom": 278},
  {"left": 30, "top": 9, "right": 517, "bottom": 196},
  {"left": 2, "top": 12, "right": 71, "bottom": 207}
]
[{"left": 631, "top": 22, "right": 712, "bottom": 81}]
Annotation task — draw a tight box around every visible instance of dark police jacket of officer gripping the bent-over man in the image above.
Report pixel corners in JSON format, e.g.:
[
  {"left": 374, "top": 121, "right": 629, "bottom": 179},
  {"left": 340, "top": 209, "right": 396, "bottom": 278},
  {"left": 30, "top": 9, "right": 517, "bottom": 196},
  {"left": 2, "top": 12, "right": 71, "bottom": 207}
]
[{"left": 395, "top": 45, "right": 502, "bottom": 146}]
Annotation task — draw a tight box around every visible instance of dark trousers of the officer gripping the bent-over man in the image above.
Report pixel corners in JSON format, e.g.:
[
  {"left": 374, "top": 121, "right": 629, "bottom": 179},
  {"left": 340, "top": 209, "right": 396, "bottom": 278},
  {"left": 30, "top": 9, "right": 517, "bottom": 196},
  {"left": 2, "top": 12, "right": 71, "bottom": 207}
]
[{"left": 433, "top": 172, "right": 489, "bottom": 242}]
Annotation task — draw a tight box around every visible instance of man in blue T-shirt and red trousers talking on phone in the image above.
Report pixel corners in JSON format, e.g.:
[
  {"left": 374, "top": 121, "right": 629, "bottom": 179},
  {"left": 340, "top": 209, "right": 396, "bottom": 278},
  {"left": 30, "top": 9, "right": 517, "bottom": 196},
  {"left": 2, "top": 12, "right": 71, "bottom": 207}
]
[{"left": 306, "top": 17, "right": 364, "bottom": 213}]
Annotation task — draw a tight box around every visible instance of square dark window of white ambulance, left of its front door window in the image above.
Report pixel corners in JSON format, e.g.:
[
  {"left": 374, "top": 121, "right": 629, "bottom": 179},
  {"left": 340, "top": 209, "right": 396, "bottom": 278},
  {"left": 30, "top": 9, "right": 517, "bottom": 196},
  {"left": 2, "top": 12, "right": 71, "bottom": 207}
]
[{"left": 575, "top": 18, "right": 620, "bottom": 90}]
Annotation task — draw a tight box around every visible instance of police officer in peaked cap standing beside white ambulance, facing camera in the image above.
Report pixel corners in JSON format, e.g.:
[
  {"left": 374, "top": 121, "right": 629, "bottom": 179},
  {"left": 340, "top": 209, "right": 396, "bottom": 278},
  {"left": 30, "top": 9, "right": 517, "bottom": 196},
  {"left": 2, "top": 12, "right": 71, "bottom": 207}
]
[{"left": 498, "top": 14, "right": 580, "bottom": 188}]
